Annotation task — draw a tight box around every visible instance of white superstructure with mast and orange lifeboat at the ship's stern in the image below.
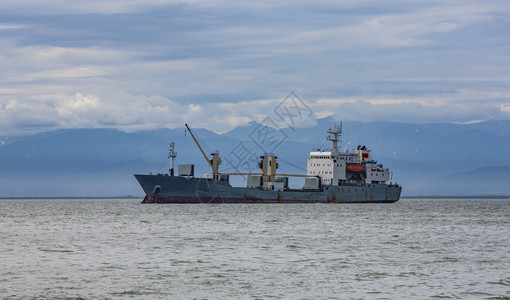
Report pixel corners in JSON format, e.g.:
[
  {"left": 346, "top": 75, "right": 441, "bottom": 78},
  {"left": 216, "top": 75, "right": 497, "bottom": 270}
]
[{"left": 306, "top": 124, "right": 390, "bottom": 186}]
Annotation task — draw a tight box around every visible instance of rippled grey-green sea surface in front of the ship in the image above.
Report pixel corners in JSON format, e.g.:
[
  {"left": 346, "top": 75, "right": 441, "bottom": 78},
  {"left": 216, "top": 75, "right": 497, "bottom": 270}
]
[{"left": 0, "top": 199, "right": 510, "bottom": 299}]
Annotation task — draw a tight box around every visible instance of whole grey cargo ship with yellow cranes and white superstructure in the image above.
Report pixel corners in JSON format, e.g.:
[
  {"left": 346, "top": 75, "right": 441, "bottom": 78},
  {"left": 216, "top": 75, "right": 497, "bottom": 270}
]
[{"left": 134, "top": 123, "right": 402, "bottom": 203}]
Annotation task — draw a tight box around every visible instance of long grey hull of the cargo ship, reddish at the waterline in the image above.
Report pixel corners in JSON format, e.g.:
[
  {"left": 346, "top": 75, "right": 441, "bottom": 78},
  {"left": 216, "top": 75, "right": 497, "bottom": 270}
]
[{"left": 135, "top": 174, "right": 402, "bottom": 203}]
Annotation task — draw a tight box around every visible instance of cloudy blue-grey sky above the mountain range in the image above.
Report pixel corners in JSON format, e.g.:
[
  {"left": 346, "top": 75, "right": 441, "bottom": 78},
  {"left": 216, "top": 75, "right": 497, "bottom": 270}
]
[{"left": 0, "top": 0, "right": 510, "bottom": 136}]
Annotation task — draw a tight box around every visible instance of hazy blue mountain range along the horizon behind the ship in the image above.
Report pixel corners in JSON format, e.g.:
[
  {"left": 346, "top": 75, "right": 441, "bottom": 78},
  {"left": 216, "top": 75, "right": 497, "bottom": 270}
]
[{"left": 0, "top": 118, "right": 510, "bottom": 197}]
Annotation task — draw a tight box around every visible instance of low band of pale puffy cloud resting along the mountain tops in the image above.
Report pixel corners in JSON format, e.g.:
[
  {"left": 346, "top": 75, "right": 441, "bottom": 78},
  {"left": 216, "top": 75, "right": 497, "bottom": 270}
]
[{"left": 0, "top": 93, "right": 510, "bottom": 135}]
